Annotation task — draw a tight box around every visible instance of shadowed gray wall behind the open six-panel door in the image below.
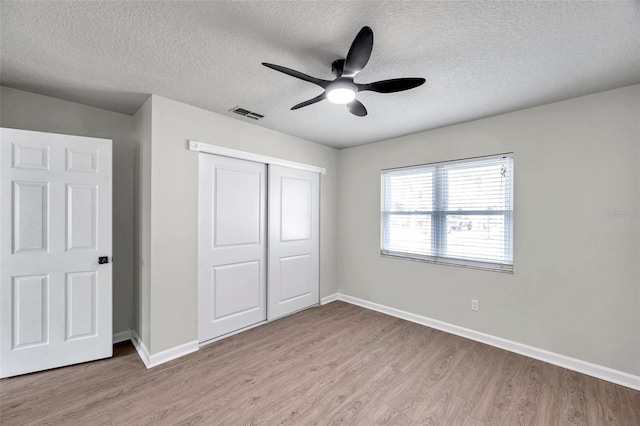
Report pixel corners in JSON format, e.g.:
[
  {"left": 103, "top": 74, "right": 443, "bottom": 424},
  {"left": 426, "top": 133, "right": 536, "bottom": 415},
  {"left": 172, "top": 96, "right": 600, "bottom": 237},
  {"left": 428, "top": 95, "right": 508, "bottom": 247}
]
[{"left": 0, "top": 87, "right": 135, "bottom": 333}]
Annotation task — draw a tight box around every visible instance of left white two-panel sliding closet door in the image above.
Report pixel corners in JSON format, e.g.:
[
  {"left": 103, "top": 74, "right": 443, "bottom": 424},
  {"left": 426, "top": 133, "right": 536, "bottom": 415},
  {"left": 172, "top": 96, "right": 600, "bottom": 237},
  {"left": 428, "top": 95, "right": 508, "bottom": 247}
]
[{"left": 198, "top": 154, "right": 267, "bottom": 343}]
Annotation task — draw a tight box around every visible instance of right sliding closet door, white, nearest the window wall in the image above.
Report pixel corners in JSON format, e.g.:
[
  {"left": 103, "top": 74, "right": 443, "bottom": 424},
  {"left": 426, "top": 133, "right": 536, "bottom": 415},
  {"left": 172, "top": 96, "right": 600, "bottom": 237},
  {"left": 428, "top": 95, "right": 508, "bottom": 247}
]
[{"left": 268, "top": 166, "right": 320, "bottom": 320}]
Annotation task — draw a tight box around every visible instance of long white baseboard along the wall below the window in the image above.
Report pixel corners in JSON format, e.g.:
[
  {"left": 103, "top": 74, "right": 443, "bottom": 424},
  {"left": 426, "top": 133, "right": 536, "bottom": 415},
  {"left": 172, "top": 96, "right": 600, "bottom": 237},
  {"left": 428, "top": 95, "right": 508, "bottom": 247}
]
[{"left": 338, "top": 293, "right": 640, "bottom": 390}]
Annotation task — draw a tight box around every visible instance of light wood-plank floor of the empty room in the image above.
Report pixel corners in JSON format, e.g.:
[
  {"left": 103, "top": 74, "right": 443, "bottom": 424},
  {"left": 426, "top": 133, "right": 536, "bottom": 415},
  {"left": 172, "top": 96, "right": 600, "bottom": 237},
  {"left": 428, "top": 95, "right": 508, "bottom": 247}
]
[{"left": 0, "top": 302, "right": 640, "bottom": 426}]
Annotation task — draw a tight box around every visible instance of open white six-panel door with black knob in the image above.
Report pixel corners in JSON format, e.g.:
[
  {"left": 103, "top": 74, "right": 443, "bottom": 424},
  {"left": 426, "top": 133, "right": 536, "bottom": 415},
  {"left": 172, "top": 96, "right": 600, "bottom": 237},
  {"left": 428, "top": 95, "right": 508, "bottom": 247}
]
[{"left": 0, "top": 125, "right": 113, "bottom": 377}]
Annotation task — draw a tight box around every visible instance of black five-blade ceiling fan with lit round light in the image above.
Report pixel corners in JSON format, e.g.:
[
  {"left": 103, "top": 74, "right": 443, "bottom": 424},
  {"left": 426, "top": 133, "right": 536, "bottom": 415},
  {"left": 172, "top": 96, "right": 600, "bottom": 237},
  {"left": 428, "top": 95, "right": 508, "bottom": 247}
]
[{"left": 262, "top": 27, "right": 425, "bottom": 117}]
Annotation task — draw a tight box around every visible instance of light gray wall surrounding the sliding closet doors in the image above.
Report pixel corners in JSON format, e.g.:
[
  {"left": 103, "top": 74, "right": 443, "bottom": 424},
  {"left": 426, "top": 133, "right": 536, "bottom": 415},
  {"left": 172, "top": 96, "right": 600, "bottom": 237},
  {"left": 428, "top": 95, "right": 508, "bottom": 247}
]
[{"left": 141, "top": 96, "right": 338, "bottom": 354}]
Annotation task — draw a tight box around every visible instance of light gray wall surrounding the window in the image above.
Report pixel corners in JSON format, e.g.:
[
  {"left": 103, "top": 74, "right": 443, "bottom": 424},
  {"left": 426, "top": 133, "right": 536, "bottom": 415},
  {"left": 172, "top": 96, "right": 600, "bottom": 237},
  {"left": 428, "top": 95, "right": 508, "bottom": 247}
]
[{"left": 337, "top": 85, "right": 640, "bottom": 375}]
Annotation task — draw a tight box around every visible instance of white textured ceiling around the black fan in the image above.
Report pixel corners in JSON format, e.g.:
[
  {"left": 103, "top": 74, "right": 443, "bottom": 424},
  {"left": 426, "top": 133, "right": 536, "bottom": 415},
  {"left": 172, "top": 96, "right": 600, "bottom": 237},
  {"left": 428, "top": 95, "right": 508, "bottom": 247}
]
[{"left": 0, "top": 0, "right": 640, "bottom": 148}]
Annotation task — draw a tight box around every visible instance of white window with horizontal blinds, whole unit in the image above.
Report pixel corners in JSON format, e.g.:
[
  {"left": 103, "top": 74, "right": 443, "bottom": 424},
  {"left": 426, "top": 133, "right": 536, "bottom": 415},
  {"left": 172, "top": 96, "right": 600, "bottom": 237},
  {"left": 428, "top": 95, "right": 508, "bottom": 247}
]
[{"left": 381, "top": 154, "right": 513, "bottom": 272}]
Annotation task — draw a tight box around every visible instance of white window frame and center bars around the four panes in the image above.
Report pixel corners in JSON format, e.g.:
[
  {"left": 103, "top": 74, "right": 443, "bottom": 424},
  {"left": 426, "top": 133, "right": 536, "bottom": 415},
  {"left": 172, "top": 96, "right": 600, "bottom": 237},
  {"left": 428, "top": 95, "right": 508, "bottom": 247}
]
[{"left": 380, "top": 152, "right": 515, "bottom": 273}]
